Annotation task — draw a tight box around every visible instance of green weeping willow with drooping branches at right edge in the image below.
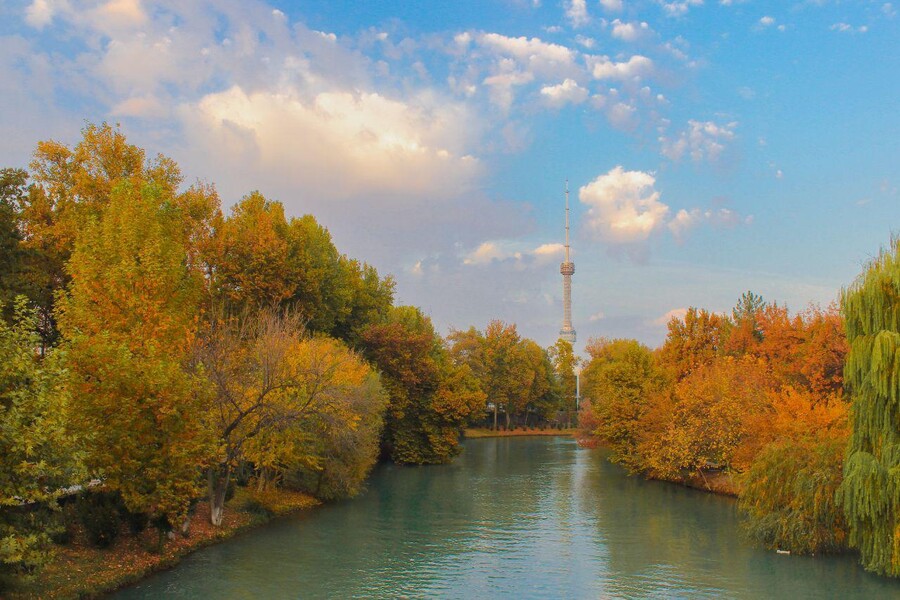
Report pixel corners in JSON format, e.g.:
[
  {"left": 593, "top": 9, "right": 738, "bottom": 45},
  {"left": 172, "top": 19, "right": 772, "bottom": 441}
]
[{"left": 837, "top": 238, "right": 900, "bottom": 577}]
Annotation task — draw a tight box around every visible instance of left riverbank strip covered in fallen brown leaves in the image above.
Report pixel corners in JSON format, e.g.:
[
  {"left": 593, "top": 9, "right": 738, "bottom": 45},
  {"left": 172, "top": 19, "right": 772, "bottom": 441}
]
[{"left": 6, "top": 489, "right": 320, "bottom": 600}]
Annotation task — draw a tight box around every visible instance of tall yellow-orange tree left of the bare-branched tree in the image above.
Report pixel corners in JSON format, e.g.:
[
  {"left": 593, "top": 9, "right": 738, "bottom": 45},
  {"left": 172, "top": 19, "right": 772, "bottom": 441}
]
[{"left": 57, "top": 181, "right": 210, "bottom": 524}]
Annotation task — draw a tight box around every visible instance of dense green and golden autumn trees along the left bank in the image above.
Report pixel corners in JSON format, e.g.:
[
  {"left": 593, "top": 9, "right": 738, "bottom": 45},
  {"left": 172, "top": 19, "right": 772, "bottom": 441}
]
[{"left": 0, "top": 124, "right": 574, "bottom": 585}]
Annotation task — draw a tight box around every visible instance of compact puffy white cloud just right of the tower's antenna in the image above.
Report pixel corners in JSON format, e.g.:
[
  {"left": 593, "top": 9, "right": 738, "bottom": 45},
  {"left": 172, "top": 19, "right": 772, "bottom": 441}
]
[{"left": 578, "top": 166, "right": 669, "bottom": 244}]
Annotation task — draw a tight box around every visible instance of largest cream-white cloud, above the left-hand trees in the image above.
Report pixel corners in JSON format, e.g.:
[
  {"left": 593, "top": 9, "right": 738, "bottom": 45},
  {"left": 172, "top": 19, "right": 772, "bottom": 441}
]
[{"left": 182, "top": 85, "right": 480, "bottom": 197}]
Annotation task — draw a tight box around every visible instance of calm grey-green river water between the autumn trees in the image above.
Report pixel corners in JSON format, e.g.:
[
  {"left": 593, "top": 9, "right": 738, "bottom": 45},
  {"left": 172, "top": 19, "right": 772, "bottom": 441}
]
[{"left": 116, "top": 437, "right": 900, "bottom": 599}]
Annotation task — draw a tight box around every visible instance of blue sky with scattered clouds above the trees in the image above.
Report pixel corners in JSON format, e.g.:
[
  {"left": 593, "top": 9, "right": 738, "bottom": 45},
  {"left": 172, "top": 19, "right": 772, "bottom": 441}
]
[{"left": 0, "top": 0, "right": 900, "bottom": 347}]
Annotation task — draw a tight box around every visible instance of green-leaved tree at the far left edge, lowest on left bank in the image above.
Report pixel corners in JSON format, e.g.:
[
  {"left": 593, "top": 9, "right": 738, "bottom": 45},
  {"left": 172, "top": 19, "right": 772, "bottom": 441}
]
[{"left": 0, "top": 296, "right": 84, "bottom": 592}]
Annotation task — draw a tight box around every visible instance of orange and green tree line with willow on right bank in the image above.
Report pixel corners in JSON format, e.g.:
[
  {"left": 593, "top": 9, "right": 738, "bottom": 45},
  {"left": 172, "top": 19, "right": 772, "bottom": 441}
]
[{"left": 580, "top": 248, "right": 900, "bottom": 576}]
